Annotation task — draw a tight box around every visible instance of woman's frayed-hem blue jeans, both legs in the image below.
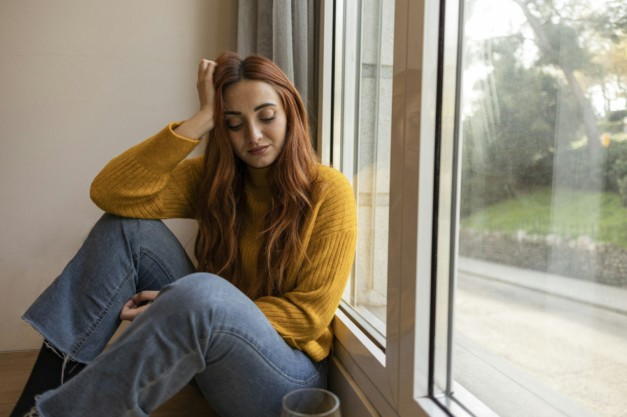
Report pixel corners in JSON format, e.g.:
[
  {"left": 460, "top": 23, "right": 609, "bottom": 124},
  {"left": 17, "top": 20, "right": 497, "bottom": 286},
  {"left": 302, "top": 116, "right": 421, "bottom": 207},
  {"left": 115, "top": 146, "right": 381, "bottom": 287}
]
[{"left": 24, "top": 215, "right": 326, "bottom": 417}]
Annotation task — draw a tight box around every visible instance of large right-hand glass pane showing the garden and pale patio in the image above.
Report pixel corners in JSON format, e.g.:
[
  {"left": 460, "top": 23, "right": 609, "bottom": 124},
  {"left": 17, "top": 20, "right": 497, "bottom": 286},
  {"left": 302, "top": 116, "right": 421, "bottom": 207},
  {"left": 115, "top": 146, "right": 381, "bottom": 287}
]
[{"left": 444, "top": 0, "right": 627, "bottom": 417}]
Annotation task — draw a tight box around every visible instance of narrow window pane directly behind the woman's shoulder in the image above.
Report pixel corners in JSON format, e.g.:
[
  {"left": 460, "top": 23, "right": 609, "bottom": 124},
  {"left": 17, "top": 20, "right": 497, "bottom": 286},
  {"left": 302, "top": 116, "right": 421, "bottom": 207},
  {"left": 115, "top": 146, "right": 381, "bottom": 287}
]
[{"left": 334, "top": 0, "right": 394, "bottom": 343}]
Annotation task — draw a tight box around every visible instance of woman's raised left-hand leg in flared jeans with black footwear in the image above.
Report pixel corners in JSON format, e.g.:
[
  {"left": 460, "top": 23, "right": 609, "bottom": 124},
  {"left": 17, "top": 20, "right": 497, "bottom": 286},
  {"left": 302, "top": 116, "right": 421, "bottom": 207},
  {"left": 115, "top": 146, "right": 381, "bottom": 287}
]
[{"left": 11, "top": 215, "right": 194, "bottom": 417}]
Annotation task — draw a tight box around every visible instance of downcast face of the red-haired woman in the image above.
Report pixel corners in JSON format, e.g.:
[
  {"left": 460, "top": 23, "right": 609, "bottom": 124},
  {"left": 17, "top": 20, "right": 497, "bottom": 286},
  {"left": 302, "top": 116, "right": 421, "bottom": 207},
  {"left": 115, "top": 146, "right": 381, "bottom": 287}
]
[{"left": 224, "top": 80, "right": 287, "bottom": 168}]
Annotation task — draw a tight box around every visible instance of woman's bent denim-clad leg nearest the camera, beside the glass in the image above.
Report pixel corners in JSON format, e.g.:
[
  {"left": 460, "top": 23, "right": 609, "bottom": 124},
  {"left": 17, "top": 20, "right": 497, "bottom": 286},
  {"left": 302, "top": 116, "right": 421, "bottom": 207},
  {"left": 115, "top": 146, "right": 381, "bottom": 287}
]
[{"left": 37, "top": 273, "right": 326, "bottom": 417}]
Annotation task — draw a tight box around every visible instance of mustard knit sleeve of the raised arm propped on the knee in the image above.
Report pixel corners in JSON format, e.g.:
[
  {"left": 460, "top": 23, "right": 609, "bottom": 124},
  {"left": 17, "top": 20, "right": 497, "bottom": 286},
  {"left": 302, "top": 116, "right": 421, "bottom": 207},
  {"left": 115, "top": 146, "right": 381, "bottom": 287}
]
[{"left": 90, "top": 123, "right": 202, "bottom": 219}]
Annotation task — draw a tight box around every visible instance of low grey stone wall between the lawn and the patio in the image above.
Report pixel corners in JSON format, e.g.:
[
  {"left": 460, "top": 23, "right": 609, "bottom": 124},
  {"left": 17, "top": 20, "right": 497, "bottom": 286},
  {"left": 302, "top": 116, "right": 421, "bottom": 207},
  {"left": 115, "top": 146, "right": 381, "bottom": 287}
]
[{"left": 459, "top": 229, "right": 627, "bottom": 287}]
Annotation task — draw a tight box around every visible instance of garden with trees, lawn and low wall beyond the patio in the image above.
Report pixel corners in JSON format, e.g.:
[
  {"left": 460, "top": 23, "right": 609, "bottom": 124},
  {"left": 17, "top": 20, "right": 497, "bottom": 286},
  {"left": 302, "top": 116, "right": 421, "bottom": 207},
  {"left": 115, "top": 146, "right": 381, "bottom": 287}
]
[{"left": 459, "top": 0, "right": 627, "bottom": 287}]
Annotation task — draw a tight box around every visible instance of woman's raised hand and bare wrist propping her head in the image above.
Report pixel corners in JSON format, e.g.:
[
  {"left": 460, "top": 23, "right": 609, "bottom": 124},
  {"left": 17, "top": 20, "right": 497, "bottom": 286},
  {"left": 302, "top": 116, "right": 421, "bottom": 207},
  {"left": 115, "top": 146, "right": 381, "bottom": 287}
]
[{"left": 174, "top": 59, "right": 216, "bottom": 139}]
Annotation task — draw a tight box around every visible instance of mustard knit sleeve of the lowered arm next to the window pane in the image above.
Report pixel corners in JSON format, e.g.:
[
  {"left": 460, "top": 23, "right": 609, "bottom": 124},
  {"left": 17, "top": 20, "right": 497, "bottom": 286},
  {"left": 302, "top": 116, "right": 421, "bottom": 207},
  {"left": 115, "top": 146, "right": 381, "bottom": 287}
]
[{"left": 255, "top": 168, "right": 357, "bottom": 360}]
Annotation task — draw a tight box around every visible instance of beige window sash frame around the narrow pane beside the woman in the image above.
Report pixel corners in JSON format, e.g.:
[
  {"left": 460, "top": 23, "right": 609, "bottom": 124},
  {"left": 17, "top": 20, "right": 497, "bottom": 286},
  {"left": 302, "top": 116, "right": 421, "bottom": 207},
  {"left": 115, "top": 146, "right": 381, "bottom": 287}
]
[{"left": 319, "top": 0, "right": 456, "bottom": 417}]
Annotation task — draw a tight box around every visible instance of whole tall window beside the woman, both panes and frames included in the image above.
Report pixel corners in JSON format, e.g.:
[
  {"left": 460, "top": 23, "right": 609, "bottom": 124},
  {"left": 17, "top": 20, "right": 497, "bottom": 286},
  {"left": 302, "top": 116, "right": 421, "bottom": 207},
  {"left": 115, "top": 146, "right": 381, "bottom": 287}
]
[{"left": 323, "top": 0, "right": 627, "bottom": 417}]
